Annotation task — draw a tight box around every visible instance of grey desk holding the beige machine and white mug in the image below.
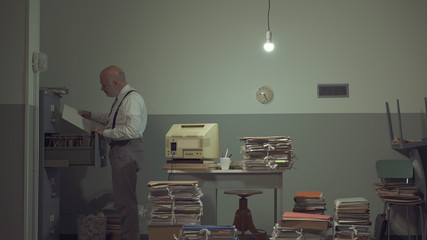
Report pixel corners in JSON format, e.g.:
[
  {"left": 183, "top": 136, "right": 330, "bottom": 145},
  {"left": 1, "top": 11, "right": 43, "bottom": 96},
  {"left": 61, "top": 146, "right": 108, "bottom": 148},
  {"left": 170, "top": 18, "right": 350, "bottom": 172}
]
[{"left": 168, "top": 169, "right": 284, "bottom": 225}]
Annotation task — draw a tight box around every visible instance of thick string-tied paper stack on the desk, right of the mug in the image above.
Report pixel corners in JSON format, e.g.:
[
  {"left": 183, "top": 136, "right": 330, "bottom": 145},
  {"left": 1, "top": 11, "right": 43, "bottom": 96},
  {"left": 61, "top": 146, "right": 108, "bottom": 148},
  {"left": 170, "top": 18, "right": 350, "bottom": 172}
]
[{"left": 240, "top": 136, "right": 294, "bottom": 170}]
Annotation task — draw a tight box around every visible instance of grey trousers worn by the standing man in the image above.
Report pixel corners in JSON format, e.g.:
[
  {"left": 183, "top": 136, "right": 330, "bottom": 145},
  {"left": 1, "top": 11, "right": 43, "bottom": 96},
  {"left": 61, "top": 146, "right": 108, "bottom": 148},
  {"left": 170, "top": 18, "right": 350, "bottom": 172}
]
[{"left": 109, "top": 139, "right": 144, "bottom": 240}]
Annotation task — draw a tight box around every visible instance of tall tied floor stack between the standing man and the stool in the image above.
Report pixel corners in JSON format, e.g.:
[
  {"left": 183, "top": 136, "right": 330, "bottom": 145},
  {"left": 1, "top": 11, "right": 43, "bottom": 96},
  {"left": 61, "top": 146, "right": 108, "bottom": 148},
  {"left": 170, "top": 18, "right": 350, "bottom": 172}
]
[{"left": 147, "top": 181, "right": 203, "bottom": 225}]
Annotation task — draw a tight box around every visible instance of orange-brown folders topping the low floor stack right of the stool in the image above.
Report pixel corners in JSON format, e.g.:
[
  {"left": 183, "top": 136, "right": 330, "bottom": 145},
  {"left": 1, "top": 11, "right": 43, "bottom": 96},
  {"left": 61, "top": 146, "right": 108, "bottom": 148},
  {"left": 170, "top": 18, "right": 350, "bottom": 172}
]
[{"left": 279, "top": 212, "right": 332, "bottom": 231}]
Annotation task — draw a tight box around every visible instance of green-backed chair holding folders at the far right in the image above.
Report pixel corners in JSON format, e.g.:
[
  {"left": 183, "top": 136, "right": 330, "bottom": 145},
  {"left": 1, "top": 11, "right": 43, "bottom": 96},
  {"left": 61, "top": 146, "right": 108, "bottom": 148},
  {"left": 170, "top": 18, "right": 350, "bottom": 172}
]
[{"left": 376, "top": 160, "right": 424, "bottom": 240}]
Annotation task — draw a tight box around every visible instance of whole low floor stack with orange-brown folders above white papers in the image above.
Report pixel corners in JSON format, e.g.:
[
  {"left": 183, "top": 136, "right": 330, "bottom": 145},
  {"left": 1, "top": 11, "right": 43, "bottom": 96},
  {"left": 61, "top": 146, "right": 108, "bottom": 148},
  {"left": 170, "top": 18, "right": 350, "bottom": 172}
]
[{"left": 271, "top": 212, "right": 332, "bottom": 240}]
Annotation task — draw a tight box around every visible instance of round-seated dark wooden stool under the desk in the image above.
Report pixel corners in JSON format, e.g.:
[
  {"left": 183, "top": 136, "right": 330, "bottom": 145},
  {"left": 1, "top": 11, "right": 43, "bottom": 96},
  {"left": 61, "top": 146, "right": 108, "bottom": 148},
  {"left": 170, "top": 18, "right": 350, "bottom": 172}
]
[{"left": 224, "top": 190, "right": 267, "bottom": 240}]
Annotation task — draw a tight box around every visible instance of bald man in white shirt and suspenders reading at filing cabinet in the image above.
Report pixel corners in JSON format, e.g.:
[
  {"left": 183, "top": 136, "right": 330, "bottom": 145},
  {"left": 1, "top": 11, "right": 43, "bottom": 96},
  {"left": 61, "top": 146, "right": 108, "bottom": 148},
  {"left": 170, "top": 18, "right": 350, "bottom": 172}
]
[{"left": 78, "top": 66, "right": 147, "bottom": 240}]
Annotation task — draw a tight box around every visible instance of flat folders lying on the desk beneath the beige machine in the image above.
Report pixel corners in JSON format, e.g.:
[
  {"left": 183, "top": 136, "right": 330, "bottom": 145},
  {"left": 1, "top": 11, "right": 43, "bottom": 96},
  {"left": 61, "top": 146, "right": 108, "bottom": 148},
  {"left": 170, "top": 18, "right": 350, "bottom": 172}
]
[{"left": 162, "top": 160, "right": 218, "bottom": 171}]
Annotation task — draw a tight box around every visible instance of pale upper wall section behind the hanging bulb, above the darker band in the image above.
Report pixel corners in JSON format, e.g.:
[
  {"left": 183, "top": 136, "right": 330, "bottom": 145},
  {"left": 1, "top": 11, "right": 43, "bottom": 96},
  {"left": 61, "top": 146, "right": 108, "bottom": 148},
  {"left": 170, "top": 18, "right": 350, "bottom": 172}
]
[{"left": 41, "top": 0, "right": 427, "bottom": 114}]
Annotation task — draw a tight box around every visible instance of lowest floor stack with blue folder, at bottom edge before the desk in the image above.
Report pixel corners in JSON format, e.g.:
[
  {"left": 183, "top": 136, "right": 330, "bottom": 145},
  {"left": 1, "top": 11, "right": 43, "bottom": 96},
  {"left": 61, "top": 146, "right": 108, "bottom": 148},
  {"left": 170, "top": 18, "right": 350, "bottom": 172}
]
[{"left": 179, "top": 225, "right": 238, "bottom": 240}]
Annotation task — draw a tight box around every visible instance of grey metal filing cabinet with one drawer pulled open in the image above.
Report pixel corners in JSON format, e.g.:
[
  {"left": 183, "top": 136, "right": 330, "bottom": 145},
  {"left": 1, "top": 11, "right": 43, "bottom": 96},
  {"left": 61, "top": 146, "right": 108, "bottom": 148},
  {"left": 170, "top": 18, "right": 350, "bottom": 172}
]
[{"left": 38, "top": 90, "right": 106, "bottom": 240}]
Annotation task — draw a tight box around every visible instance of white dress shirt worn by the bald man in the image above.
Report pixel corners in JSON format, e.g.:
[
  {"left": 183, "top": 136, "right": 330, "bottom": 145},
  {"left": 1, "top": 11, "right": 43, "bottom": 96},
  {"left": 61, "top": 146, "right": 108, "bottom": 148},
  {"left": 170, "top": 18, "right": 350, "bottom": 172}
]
[{"left": 92, "top": 84, "right": 147, "bottom": 140}]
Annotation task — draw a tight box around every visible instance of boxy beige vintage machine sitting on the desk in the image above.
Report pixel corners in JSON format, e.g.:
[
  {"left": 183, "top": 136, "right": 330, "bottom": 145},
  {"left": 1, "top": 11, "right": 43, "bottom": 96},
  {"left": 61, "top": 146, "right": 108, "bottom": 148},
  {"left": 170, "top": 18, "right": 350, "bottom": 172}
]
[{"left": 166, "top": 123, "right": 219, "bottom": 161}]
